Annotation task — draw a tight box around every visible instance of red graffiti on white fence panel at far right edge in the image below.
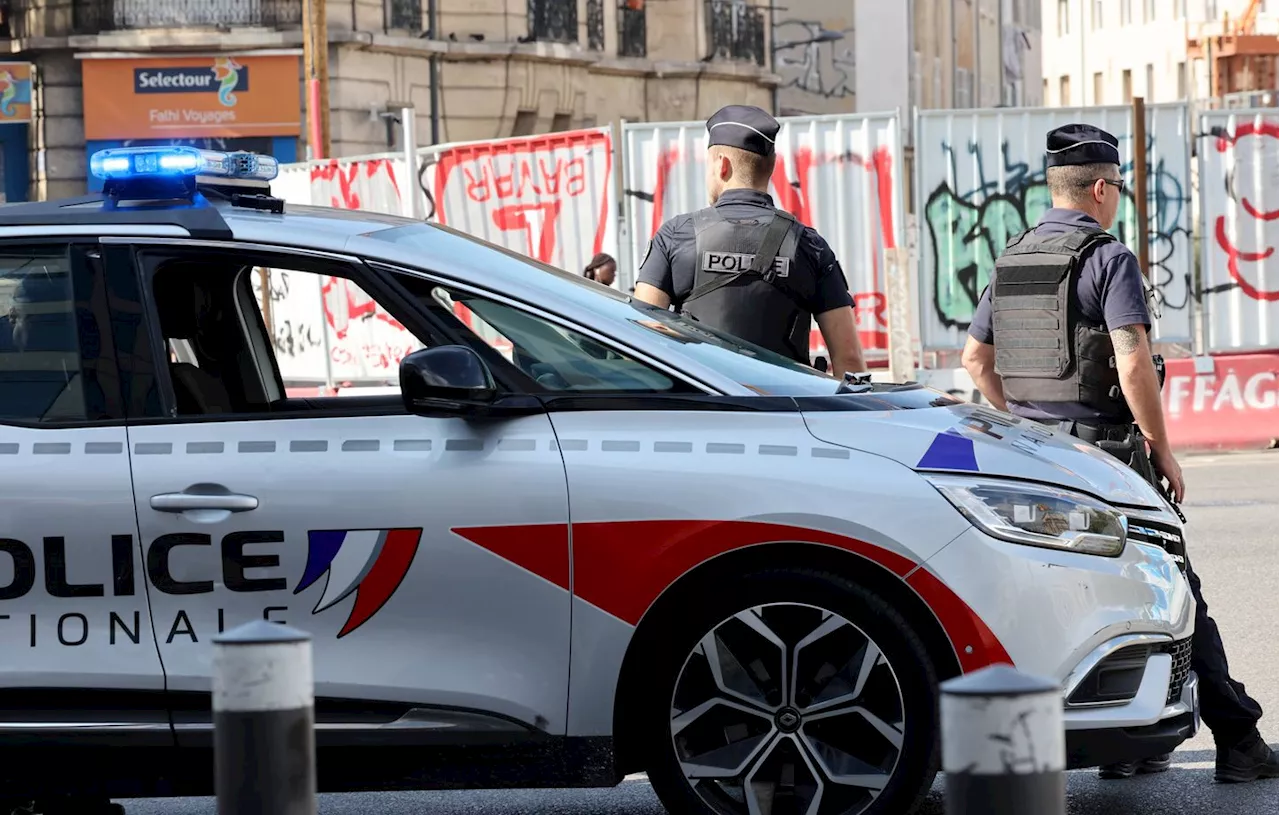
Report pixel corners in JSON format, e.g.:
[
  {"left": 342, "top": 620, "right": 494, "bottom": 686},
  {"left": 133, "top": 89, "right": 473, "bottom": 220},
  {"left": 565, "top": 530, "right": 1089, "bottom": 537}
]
[{"left": 1206, "top": 118, "right": 1280, "bottom": 302}]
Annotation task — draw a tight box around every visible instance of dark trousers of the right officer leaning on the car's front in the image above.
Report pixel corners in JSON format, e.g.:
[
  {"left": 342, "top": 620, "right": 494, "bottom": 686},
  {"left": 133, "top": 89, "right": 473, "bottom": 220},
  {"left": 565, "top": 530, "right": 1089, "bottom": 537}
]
[{"left": 1046, "top": 422, "right": 1262, "bottom": 747}]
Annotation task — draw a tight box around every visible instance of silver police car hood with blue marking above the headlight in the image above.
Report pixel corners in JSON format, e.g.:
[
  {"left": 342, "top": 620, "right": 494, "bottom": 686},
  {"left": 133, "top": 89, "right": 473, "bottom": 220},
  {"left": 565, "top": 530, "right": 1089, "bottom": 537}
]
[{"left": 799, "top": 389, "right": 1167, "bottom": 509}]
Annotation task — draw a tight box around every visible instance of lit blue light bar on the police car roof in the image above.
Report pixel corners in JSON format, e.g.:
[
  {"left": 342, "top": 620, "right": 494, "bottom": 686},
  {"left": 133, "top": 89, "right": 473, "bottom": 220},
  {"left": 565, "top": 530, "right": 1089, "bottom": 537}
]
[{"left": 88, "top": 146, "right": 280, "bottom": 182}]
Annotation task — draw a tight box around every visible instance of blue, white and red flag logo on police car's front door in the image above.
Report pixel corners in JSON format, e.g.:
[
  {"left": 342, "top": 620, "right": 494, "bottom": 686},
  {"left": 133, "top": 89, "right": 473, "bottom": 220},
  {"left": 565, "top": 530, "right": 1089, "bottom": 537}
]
[{"left": 293, "top": 528, "right": 422, "bottom": 640}]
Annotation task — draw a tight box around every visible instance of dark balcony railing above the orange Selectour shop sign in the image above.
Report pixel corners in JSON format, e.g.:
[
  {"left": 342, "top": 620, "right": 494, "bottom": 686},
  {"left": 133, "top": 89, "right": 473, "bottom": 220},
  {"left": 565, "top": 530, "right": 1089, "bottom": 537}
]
[{"left": 12, "top": 0, "right": 302, "bottom": 37}]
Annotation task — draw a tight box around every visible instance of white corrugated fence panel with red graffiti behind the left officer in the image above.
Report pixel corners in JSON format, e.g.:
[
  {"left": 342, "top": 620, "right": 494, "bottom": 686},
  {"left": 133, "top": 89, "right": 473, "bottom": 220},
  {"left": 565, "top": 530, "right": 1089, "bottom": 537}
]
[{"left": 620, "top": 114, "right": 905, "bottom": 354}]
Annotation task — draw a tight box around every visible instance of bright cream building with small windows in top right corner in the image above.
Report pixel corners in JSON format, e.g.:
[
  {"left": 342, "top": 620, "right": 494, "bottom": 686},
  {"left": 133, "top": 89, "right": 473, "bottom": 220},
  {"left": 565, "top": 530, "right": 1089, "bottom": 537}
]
[{"left": 1042, "top": 0, "right": 1280, "bottom": 106}]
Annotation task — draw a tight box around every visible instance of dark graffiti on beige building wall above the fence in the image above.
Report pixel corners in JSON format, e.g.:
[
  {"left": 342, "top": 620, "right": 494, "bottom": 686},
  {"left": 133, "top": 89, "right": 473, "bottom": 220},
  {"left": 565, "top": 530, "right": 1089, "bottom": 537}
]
[{"left": 774, "top": 19, "right": 855, "bottom": 99}]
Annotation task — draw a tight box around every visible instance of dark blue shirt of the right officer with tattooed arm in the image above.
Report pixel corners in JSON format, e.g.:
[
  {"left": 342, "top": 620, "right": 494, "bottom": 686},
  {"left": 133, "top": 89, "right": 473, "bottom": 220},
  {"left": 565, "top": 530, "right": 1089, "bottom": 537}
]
[{"left": 969, "top": 207, "right": 1151, "bottom": 420}]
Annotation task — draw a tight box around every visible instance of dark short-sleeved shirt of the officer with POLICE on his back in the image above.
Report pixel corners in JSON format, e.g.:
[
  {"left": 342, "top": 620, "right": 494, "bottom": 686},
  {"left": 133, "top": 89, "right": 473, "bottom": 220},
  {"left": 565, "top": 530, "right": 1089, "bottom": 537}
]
[{"left": 639, "top": 189, "right": 854, "bottom": 315}]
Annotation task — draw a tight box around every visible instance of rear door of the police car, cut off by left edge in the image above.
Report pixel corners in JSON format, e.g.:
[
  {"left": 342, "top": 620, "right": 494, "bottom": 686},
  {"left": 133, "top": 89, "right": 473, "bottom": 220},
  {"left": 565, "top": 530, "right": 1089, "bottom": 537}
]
[{"left": 0, "top": 237, "right": 173, "bottom": 745}]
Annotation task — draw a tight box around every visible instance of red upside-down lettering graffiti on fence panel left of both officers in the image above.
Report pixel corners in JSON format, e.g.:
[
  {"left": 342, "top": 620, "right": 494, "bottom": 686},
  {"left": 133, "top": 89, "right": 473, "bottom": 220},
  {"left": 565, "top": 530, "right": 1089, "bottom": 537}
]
[{"left": 434, "top": 131, "right": 613, "bottom": 264}]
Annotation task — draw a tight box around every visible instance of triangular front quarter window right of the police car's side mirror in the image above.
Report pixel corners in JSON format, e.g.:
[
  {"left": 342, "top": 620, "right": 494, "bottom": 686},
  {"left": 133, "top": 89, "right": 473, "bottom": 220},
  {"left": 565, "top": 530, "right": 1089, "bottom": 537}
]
[{"left": 398, "top": 275, "right": 695, "bottom": 394}]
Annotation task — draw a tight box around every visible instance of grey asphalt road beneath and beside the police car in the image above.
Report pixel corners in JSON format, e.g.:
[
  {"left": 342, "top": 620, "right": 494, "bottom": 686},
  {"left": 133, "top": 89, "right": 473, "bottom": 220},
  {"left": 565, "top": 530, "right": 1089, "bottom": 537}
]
[{"left": 112, "top": 452, "right": 1280, "bottom": 815}]
